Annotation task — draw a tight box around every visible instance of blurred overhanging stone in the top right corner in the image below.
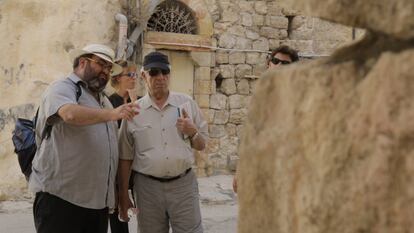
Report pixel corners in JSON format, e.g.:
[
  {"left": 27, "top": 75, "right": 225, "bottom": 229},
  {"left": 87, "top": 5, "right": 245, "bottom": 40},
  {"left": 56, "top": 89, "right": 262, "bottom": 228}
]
[{"left": 284, "top": 0, "right": 414, "bottom": 39}]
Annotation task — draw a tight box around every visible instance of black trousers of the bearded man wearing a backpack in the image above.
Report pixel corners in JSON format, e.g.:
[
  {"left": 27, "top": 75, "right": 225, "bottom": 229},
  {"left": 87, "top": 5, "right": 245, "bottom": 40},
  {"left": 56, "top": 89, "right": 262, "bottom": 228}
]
[{"left": 33, "top": 192, "right": 108, "bottom": 233}]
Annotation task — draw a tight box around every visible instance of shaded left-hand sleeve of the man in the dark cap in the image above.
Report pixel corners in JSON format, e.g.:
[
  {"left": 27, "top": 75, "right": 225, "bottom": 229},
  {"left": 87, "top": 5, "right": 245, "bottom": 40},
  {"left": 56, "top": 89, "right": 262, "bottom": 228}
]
[{"left": 118, "top": 120, "right": 134, "bottom": 160}]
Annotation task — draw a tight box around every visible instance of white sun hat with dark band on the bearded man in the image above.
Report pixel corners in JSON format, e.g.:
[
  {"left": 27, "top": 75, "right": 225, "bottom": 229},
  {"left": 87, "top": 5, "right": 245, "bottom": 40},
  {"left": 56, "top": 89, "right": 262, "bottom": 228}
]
[{"left": 70, "top": 44, "right": 122, "bottom": 76}]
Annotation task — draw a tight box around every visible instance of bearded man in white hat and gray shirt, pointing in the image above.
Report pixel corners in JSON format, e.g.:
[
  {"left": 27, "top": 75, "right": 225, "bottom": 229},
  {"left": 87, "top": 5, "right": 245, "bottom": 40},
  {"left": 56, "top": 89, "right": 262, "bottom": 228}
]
[{"left": 29, "top": 44, "right": 138, "bottom": 233}]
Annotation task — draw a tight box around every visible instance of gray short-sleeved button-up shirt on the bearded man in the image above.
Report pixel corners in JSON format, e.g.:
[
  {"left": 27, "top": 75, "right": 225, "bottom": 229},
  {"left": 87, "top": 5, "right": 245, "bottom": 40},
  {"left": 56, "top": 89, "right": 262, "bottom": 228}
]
[{"left": 29, "top": 74, "right": 118, "bottom": 209}]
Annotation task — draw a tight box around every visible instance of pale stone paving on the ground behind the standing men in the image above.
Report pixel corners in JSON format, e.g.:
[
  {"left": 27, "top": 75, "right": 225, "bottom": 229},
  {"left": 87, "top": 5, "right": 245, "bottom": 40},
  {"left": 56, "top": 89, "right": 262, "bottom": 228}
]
[{"left": 0, "top": 175, "right": 238, "bottom": 233}]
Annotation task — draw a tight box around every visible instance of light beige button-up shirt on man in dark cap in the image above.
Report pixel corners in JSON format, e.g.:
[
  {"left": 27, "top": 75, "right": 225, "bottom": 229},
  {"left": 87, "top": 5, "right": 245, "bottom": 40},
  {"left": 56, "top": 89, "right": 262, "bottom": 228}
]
[{"left": 119, "top": 92, "right": 208, "bottom": 177}]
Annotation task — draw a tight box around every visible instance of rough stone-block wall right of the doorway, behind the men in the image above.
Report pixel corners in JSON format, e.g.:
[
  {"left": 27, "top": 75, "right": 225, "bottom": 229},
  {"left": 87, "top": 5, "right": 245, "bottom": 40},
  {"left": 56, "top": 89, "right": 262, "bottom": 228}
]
[{"left": 201, "top": 0, "right": 356, "bottom": 175}]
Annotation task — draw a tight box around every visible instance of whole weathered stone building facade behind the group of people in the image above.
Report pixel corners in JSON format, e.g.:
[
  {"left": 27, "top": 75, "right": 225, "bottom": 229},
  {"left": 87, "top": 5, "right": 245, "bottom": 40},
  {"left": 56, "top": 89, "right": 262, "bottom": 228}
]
[{"left": 0, "top": 0, "right": 358, "bottom": 196}]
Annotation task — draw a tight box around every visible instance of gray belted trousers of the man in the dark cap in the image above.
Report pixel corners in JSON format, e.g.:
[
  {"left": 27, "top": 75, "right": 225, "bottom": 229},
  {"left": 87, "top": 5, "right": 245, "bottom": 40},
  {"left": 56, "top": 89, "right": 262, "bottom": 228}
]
[{"left": 134, "top": 171, "right": 203, "bottom": 233}]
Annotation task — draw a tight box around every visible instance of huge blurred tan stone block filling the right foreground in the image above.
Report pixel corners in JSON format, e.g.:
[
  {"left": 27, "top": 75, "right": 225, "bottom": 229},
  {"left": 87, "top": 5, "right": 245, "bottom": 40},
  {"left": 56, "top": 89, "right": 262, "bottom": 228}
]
[{"left": 238, "top": 33, "right": 414, "bottom": 233}]
